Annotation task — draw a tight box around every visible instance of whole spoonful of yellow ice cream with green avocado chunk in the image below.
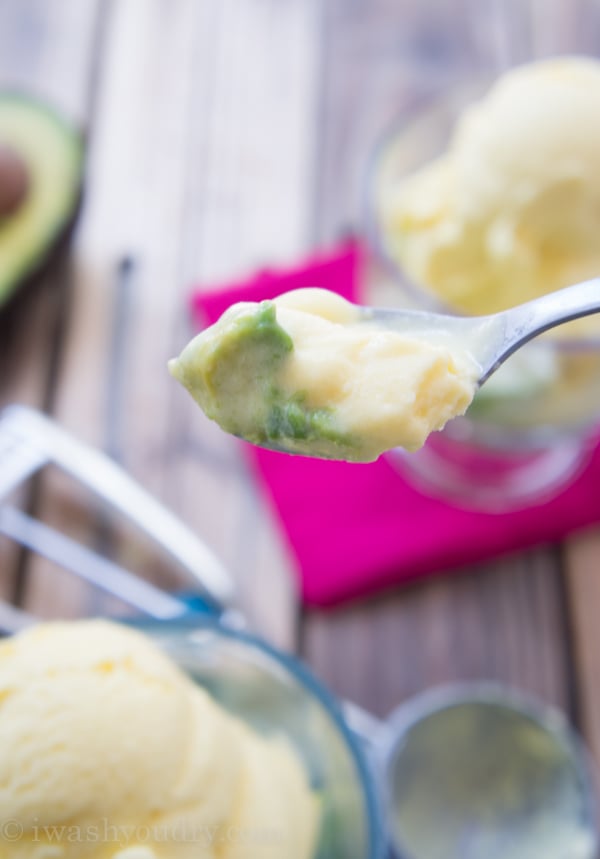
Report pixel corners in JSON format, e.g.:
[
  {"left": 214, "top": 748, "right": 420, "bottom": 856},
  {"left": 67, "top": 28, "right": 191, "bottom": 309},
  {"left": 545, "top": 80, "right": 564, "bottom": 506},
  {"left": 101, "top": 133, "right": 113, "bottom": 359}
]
[{"left": 170, "top": 289, "right": 479, "bottom": 462}]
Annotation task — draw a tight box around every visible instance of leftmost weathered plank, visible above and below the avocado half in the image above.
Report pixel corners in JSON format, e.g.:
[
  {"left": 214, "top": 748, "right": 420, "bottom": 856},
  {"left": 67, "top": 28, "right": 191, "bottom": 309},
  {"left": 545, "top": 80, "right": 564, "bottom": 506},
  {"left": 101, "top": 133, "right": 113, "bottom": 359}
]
[{"left": 0, "top": 0, "right": 101, "bottom": 598}]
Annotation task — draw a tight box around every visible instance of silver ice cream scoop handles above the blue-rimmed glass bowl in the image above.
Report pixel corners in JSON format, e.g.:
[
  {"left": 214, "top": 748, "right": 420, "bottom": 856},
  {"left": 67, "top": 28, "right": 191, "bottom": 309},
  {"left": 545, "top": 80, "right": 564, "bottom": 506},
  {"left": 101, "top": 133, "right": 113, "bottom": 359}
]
[{"left": 0, "top": 406, "right": 233, "bottom": 619}]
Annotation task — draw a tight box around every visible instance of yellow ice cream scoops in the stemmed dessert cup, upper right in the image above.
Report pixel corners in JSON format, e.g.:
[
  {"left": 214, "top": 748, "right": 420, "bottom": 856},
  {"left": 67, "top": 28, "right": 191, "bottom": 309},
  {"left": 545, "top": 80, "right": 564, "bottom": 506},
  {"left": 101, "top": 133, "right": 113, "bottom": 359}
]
[{"left": 380, "top": 57, "right": 600, "bottom": 313}]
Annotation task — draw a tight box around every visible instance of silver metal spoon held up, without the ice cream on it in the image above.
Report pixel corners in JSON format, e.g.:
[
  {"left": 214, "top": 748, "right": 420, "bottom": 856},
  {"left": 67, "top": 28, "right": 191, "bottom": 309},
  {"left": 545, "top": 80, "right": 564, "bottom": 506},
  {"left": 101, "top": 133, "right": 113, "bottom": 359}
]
[{"left": 359, "top": 278, "right": 600, "bottom": 386}]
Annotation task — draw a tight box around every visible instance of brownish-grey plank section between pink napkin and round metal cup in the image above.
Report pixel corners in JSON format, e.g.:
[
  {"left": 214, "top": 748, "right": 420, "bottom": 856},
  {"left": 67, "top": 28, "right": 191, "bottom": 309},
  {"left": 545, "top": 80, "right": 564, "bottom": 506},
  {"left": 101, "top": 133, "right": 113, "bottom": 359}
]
[{"left": 303, "top": 551, "right": 570, "bottom": 716}]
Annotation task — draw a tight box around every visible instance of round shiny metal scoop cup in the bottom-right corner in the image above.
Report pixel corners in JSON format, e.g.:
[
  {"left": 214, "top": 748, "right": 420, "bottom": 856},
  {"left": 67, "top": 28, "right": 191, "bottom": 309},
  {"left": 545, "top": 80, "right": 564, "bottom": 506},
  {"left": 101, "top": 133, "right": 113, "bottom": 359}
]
[{"left": 384, "top": 683, "right": 599, "bottom": 859}]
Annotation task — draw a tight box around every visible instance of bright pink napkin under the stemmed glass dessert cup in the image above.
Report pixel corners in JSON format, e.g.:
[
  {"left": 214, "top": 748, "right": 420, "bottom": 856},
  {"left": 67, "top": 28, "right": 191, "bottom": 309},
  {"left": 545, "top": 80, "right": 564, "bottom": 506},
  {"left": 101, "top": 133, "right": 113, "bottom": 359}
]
[{"left": 192, "top": 243, "right": 600, "bottom": 606}]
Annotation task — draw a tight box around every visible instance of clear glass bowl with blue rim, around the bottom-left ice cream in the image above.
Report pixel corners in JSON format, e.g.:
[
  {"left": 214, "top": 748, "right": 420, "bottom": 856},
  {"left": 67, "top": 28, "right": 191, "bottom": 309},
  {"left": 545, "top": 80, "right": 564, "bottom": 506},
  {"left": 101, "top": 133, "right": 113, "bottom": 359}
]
[{"left": 135, "top": 617, "right": 387, "bottom": 859}]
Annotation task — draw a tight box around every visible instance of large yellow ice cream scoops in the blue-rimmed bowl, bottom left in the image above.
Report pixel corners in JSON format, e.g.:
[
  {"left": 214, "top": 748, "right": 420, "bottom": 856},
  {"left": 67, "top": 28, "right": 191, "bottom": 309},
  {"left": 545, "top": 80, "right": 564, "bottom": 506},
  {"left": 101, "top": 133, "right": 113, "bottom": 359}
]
[{"left": 0, "top": 621, "right": 317, "bottom": 859}]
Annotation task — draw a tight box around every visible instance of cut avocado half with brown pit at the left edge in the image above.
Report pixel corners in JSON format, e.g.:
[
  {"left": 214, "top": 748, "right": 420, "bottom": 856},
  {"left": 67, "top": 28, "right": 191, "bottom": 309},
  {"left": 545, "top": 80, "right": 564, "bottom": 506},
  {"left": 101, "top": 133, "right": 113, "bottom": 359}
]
[{"left": 0, "top": 92, "right": 84, "bottom": 305}]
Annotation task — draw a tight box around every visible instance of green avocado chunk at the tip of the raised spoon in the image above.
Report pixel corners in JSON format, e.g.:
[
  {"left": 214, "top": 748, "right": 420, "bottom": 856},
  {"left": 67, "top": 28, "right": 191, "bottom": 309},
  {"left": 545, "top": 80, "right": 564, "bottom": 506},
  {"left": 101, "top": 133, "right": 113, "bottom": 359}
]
[{"left": 169, "top": 301, "right": 356, "bottom": 459}]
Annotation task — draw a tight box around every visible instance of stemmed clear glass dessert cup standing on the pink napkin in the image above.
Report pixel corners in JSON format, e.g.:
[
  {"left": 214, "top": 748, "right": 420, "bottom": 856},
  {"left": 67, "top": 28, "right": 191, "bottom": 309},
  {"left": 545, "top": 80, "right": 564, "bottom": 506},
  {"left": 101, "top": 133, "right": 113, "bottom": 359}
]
[{"left": 364, "top": 81, "right": 600, "bottom": 511}]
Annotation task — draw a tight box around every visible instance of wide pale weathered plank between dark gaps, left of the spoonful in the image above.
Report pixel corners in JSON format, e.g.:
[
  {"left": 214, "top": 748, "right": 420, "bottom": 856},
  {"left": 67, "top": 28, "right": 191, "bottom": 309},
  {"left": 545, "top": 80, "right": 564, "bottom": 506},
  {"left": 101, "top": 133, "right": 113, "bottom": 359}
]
[{"left": 21, "top": 0, "right": 316, "bottom": 645}]
